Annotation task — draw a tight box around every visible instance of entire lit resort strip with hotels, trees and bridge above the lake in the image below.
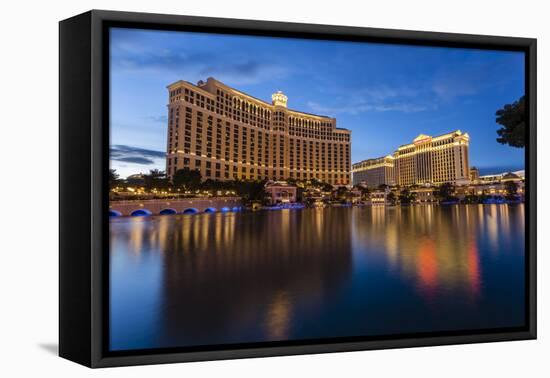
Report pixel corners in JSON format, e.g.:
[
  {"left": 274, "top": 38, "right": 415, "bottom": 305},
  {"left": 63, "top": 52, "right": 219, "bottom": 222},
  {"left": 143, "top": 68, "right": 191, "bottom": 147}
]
[{"left": 110, "top": 78, "right": 525, "bottom": 215}]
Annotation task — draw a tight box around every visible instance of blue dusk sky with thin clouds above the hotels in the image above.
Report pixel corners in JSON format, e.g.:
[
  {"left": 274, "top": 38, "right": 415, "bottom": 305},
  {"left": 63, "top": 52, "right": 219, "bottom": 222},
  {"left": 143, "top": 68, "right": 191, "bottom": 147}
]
[{"left": 110, "top": 29, "right": 525, "bottom": 177}]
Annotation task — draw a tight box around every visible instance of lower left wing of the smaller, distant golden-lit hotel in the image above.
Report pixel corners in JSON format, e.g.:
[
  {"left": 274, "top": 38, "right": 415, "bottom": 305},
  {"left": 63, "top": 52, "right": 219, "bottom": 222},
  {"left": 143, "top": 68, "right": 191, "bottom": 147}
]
[{"left": 351, "top": 155, "right": 396, "bottom": 188}]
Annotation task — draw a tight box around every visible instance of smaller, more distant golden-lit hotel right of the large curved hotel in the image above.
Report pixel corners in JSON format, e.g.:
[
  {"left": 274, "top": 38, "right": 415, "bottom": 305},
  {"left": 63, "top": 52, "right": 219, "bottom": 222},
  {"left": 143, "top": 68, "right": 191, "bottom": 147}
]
[{"left": 352, "top": 130, "right": 470, "bottom": 187}]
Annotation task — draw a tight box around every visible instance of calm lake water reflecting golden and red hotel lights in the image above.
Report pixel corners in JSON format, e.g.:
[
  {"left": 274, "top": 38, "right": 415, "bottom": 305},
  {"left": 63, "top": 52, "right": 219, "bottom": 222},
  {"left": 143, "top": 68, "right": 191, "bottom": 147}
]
[{"left": 110, "top": 205, "right": 525, "bottom": 350}]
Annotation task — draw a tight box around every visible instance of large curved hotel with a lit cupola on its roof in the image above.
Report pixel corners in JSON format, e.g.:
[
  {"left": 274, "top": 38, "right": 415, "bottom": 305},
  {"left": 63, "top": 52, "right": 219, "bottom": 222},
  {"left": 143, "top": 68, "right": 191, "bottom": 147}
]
[{"left": 166, "top": 78, "right": 351, "bottom": 185}]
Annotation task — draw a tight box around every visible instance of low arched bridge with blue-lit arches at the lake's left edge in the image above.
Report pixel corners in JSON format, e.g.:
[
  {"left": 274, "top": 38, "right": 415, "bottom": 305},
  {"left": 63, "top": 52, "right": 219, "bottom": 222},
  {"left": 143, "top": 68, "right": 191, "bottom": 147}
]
[{"left": 109, "top": 197, "right": 242, "bottom": 217}]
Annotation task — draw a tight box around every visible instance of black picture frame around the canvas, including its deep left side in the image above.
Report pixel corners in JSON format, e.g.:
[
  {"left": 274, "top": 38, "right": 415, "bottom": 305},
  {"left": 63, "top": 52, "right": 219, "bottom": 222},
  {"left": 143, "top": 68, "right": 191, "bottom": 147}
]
[{"left": 59, "top": 10, "right": 537, "bottom": 368}]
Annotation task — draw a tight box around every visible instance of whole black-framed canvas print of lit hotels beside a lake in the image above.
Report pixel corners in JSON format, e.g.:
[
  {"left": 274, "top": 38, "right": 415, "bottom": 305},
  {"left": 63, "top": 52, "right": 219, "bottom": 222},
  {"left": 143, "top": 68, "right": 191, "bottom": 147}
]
[{"left": 59, "top": 11, "right": 536, "bottom": 367}]
